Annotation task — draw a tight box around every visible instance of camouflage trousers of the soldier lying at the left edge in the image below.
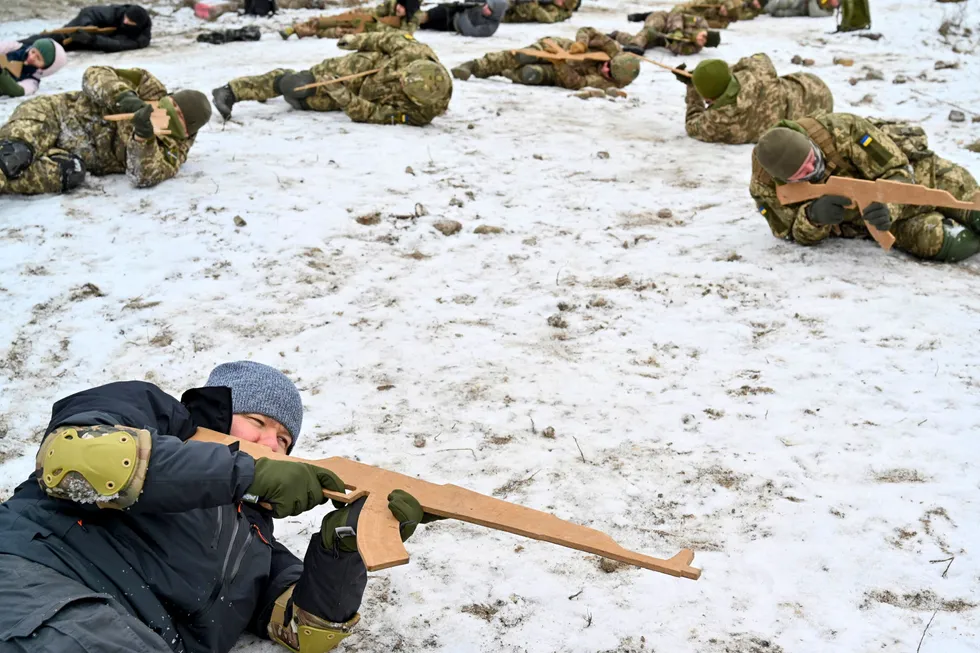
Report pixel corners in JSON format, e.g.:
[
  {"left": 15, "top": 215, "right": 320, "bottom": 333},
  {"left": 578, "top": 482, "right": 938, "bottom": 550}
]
[{"left": 0, "top": 96, "right": 69, "bottom": 195}]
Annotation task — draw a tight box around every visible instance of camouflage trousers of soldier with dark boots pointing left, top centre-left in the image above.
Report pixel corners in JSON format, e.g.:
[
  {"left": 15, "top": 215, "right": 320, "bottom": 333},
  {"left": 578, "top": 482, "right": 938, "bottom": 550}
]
[{"left": 228, "top": 52, "right": 381, "bottom": 111}]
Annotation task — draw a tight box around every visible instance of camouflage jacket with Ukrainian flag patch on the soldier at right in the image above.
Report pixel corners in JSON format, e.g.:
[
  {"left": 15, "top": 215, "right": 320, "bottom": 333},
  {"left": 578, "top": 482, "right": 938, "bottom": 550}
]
[{"left": 749, "top": 113, "right": 921, "bottom": 245}]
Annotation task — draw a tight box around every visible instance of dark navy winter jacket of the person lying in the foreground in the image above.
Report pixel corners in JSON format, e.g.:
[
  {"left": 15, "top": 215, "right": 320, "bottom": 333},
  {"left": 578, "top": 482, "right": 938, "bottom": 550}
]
[{"left": 0, "top": 381, "right": 302, "bottom": 653}]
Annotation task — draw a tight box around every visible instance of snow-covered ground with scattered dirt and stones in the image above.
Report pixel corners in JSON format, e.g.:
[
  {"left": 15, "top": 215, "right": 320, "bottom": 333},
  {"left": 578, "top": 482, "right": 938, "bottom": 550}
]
[{"left": 0, "top": 0, "right": 980, "bottom": 653}]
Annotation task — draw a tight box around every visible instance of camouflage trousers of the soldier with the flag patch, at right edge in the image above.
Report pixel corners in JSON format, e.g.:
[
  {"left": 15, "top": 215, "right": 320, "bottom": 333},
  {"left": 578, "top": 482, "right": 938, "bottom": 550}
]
[{"left": 891, "top": 156, "right": 980, "bottom": 258}]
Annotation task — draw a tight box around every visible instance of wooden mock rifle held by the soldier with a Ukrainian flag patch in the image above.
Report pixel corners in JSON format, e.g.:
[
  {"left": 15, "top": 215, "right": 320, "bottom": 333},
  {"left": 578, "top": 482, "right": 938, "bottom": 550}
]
[{"left": 776, "top": 176, "right": 980, "bottom": 251}]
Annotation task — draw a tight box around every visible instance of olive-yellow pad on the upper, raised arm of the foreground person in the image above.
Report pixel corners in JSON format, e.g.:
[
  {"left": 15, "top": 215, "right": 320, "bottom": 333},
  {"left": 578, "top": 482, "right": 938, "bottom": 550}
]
[{"left": 36, "top": 425, "right": 153, "bottom": 510}]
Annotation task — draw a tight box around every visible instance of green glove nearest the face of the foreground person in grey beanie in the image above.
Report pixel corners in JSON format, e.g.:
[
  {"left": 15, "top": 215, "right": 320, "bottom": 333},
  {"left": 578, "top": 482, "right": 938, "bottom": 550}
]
[{"left": 245, "top": 456, "right": 344, "bottom": 519}]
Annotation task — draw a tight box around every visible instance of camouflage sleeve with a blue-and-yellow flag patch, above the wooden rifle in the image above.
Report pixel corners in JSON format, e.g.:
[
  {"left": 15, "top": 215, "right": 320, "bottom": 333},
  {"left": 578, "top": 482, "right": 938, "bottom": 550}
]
[{"left": 826, "top": 113, "right": 915, "bottom": 220}]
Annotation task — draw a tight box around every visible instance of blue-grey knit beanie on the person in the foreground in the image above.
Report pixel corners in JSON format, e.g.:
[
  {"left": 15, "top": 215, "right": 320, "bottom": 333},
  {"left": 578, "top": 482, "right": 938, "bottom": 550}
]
[{"left": 204, "top": 361, "right": 303, "bottom": 453}]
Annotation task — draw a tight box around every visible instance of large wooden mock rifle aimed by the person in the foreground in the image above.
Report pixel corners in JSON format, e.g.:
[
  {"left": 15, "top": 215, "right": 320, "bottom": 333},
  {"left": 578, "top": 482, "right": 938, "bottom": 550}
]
[{"left": 191, "top": 429, "right": 701, "bottom": 580}]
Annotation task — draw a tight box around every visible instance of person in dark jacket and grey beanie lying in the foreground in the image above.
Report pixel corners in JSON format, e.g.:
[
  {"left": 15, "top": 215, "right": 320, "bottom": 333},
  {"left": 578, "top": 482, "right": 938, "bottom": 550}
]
[{"left": 0, "top": 361, "right": 428, "bottom": 653}]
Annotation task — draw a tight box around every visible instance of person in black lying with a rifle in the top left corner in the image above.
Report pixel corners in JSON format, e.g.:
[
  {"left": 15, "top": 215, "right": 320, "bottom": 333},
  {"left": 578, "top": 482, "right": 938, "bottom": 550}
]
[{"left": 20, "top": 5, "right": 152, "bottom": 52}]
